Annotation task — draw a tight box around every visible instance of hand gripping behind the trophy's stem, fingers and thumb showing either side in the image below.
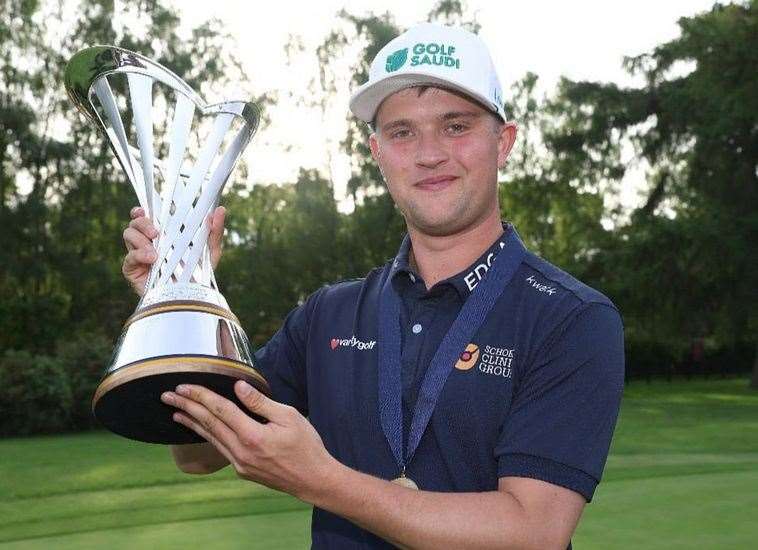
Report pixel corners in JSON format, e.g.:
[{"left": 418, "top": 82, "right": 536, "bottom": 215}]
[{"left": 121, "top": 206, "right": 226, "bottom": 296}]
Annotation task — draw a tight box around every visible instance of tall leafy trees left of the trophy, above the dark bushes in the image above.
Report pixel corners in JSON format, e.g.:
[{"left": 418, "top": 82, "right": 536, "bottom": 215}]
[{"left": 0, "top": 0, "right": 262, "bottom": 353}]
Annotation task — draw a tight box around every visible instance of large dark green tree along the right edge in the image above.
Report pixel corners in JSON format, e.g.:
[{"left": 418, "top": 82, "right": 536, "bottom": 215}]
[{"left": 550, "top": 0, "right": 758, "bottom": 378}]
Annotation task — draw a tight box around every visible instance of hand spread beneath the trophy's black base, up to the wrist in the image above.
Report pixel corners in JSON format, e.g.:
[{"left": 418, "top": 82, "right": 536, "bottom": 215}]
[{"left": 161, "top": 381, "right": 340, "bottom": 501}]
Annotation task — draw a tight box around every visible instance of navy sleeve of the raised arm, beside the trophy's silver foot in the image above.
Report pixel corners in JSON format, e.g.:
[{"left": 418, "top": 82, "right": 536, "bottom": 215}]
[{"left": 255, "top": 287, "right": 326, "bottom": 416}]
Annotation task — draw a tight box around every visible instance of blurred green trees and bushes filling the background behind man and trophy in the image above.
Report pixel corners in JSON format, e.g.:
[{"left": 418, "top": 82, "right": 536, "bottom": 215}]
[{"left": 0, "top": 0, "right": 758, "bottom": 436}]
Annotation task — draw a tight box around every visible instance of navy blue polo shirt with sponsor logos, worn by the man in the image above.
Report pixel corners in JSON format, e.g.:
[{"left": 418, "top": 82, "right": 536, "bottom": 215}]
[{"left": 256, "top": 225, "right": 624, "bottom": 548}]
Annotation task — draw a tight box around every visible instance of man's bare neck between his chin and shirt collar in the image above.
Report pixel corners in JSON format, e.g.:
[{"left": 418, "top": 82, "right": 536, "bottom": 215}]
[{"left": 408, "top": 211, "right": 503, "bottom": 289}]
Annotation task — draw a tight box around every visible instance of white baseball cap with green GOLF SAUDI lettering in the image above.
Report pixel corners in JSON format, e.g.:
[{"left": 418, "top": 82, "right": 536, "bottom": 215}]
[{"left": 350, "top": 23, "right": 506, "bottom": 123}]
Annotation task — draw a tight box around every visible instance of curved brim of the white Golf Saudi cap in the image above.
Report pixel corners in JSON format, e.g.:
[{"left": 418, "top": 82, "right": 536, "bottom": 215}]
[{"left": 350, "top": 72, "right": 505, "bottom": 123}]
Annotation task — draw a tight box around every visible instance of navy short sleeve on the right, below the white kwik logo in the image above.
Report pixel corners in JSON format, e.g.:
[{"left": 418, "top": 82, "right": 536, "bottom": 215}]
[{"left": 495, "top": 303, "right": 624, "bottom": 502}]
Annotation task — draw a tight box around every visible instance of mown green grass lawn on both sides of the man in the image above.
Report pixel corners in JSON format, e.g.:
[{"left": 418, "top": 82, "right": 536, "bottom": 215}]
[{"left": 0, "top": 379, "right": 758, "bottom": 550}]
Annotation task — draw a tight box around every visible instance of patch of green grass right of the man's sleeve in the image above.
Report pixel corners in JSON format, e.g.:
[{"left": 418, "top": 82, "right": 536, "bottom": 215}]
[{"left": 574, "top": 379, "right": 758, "bottom": 550}]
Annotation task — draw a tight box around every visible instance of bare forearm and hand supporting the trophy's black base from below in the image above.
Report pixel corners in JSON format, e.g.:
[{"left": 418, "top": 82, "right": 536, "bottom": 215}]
[{"left": 161, "top": 381, "right": 584, "bottom": 550}]
